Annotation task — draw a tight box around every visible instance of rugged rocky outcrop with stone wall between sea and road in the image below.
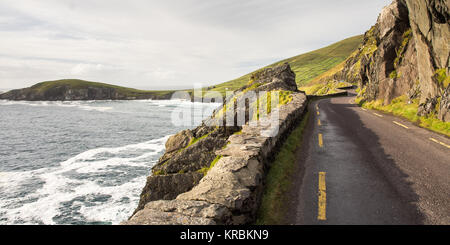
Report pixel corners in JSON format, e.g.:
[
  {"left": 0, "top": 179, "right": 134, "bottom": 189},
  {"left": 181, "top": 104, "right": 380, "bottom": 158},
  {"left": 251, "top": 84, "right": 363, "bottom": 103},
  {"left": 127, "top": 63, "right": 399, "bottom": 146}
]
[{"left": 123, "top": 64, "right": 306, "bottom": 225}]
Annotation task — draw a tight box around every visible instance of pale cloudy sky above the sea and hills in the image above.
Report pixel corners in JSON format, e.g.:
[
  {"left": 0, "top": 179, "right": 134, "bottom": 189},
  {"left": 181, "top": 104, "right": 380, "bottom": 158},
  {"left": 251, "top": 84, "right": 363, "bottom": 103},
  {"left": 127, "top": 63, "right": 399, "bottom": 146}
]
[{"left": 0, "top": 0, "right": 391, "bottom": 89}]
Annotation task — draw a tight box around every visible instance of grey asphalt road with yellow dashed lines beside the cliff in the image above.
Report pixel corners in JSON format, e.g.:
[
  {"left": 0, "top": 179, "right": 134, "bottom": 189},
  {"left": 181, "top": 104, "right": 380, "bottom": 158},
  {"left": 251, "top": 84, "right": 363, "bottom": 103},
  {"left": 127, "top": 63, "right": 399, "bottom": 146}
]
[{"left": 286, "top": 91, "right": 450, "bottom": 225}]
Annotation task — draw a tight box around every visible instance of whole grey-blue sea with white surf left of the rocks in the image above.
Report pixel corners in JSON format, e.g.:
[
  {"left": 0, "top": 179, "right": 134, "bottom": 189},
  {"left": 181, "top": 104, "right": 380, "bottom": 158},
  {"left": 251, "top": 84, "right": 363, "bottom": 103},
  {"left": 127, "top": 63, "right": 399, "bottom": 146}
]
[{"left": 0, "top": 100, "right": 219, "bottom": 225}]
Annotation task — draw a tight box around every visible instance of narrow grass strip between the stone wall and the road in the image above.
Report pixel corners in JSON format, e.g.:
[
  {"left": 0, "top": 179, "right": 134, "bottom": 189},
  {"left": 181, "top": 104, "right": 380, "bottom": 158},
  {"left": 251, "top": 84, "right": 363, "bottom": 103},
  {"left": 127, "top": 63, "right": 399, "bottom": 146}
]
[{"left": 256, "top": 113, "right": 309, "bottom": 225}]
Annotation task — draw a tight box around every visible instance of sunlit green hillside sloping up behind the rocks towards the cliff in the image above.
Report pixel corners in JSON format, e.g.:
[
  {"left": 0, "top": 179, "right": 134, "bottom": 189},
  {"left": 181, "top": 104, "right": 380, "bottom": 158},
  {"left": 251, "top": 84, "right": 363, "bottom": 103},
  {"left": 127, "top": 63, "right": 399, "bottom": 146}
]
[{"left": 208, "top": 35, "right": 363, "bottom": 93}]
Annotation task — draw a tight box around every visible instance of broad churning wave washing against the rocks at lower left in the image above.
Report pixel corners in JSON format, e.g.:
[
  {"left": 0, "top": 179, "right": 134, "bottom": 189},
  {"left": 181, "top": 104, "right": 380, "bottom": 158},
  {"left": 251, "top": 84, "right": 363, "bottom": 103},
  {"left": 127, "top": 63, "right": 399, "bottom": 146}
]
[{"left": 0, "top": 136, "right": 169, "bottom": 224}]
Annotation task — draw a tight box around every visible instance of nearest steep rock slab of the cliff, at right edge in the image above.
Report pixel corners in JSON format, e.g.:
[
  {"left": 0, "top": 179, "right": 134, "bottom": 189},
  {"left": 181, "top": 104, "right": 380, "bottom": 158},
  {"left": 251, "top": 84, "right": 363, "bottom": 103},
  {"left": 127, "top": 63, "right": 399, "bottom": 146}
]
[{"left": 405, "top": 0, "right": 450, "bottom": 122}]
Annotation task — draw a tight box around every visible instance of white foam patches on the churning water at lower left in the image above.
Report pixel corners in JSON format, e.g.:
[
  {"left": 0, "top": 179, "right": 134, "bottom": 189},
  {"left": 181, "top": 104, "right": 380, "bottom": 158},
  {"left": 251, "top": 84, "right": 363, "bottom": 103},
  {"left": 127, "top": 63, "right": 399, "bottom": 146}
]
[{"left": 0, "top": 136, "right": 169, "bottom": 224}]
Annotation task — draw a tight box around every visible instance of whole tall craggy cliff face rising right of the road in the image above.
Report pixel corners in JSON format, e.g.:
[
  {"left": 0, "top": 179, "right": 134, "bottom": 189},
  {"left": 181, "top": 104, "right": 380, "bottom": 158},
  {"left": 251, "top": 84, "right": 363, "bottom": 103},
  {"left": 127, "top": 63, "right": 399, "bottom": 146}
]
[{"left": 326, "top": 0, "right": 450, "bottom": 121}]
